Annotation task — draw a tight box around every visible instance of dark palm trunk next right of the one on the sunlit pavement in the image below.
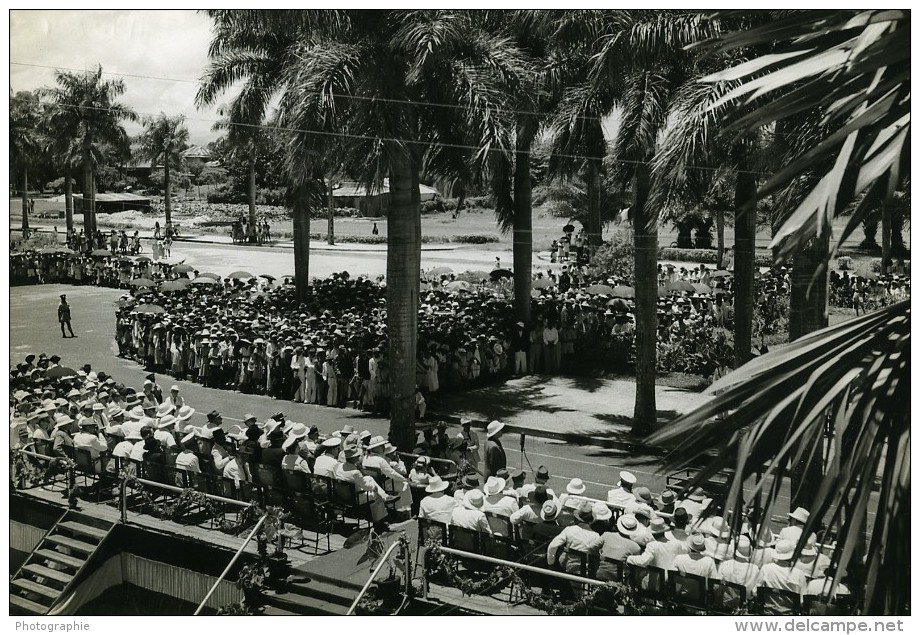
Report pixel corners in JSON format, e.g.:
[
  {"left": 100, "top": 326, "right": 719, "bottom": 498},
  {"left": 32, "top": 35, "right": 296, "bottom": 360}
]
[{"left": 735, "top": 166, "right": 757, "bottom": 368}]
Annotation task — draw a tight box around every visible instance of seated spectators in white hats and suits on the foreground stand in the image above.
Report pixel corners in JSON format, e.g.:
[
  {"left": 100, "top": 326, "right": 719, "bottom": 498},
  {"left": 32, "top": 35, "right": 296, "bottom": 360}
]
[{"left": 10, "top": 354, "right": 850, "bottom": 613}]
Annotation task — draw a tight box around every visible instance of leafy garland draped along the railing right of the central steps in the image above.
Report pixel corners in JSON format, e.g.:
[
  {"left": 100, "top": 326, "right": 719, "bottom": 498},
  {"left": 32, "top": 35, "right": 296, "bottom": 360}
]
[{"left": 425, "top": 539, "right": 636, "bottom": 615}]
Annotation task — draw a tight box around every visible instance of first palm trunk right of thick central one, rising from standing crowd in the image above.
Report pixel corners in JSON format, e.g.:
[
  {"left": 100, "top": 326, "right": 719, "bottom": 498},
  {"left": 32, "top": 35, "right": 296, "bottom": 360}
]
[{"left": 511, "top": 125, "right": 533, "bottom": 324}]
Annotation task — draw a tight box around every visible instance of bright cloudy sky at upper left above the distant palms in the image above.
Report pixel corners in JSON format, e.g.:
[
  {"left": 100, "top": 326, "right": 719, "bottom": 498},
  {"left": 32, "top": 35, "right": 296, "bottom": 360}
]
[{"left": 10, "top": 9, "right": 232, "bottom": 145}]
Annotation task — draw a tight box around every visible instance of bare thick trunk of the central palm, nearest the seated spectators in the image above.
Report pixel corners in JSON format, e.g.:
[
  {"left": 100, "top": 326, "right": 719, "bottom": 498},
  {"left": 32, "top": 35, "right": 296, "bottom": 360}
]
[{"left": 387, "top": 153, "right": 422, "bottom": 452}]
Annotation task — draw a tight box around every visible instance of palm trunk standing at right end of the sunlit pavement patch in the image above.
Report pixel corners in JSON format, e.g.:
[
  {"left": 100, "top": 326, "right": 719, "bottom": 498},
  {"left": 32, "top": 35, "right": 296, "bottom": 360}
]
[{"left": 632, "top": 164, "right": 658, "bottom": 436}]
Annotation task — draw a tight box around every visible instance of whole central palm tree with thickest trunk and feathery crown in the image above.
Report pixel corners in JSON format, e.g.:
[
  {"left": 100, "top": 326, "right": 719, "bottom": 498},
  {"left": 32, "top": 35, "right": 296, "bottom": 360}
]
[{"left": 270, "top": 10, "right": 524, "bottom": 448}]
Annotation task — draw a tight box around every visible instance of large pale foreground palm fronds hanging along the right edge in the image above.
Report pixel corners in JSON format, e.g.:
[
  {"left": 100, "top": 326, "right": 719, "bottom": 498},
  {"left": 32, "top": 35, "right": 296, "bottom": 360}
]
[{"left": 650, "top": 10, "right": 911, "bottom": 615}]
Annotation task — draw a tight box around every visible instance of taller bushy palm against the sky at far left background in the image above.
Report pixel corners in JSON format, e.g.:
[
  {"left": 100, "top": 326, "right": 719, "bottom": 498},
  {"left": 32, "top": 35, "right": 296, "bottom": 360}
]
[{"left": 38, "top": 66, "right": 137, "bottom": 236}]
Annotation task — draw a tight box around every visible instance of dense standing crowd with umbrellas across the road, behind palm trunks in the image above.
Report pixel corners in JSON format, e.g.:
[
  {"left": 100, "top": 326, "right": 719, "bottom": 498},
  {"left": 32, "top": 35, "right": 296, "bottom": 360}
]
[{"left": 10, "top": 241, "right": 910, "bottom": 388}]
